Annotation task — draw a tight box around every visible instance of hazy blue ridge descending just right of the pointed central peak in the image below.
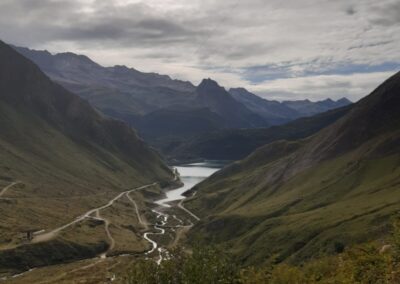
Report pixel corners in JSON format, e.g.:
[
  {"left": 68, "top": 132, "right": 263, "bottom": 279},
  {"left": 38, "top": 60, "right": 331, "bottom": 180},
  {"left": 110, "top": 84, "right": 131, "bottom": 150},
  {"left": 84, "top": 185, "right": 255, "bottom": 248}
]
[{"left": 229, "top": 88, "right": 301, "bottom": 125}]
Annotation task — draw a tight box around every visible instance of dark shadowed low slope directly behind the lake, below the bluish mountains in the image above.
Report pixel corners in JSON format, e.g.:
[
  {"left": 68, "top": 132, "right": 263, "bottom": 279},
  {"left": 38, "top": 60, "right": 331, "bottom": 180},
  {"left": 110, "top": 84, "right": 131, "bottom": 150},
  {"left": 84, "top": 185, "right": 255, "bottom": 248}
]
[{"left": 162, "top": 106, "right": 351, "bottom": 161}]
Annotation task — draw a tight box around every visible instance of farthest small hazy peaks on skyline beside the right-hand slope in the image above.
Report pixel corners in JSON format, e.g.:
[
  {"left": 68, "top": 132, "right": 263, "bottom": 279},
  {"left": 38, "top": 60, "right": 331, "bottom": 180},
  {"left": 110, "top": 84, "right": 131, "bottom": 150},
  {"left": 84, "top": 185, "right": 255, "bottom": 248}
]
[{"left": 282, "top": 98, "right": 352, "bottom": 116}]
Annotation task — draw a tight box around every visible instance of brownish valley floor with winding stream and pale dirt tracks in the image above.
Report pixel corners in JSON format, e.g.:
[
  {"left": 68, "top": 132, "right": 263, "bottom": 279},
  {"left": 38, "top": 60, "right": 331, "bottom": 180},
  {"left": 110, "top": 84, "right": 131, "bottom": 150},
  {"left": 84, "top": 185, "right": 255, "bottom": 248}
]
[{"left": 0, "top": 179, "right": 198, "bottom": 283}]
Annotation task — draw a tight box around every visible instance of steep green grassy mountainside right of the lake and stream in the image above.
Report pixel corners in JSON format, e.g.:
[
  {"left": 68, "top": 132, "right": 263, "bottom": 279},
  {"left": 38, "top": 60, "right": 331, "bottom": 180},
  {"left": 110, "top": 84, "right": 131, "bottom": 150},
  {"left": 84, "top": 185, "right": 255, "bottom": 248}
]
[{"left": 186, "top": 70, "right": 400, "bottom": 263}]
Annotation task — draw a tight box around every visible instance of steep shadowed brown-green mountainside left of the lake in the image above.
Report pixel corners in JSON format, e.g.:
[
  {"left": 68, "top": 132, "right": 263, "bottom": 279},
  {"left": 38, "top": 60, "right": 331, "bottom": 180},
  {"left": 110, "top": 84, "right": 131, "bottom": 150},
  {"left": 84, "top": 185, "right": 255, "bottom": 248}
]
[{"left": 0, "top": 42, "right": 173, "bottom": 272}]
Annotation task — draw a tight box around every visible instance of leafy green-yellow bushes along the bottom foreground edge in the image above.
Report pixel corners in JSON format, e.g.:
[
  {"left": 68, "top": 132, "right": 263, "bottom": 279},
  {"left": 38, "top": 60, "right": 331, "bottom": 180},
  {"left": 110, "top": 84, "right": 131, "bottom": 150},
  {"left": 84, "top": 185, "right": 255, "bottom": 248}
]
[{"left": 126, "top": 218, "right": 400, "bottom": 284}]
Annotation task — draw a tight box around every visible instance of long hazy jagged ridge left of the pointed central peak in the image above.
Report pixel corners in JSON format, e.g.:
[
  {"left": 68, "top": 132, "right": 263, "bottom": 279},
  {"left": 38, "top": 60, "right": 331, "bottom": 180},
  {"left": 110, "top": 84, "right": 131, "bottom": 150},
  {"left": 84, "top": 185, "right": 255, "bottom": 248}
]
[{"left": 15, "top": 47, "right": 195, "bottom": 115}]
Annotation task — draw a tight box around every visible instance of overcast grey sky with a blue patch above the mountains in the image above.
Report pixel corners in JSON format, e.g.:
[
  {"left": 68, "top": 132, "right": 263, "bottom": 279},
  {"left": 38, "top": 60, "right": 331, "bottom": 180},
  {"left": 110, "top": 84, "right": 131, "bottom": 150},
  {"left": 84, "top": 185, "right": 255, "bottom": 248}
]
[{"left": 0, "top": 0, "right": 400, "bottom": 101}]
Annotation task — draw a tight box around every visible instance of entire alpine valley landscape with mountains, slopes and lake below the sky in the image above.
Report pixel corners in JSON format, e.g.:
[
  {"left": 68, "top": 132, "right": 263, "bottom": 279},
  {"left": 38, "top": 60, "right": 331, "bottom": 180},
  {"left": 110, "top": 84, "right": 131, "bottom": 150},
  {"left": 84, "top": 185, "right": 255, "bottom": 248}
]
[{"left": 0, "top": 34, "right": 400, "bottom": 284}]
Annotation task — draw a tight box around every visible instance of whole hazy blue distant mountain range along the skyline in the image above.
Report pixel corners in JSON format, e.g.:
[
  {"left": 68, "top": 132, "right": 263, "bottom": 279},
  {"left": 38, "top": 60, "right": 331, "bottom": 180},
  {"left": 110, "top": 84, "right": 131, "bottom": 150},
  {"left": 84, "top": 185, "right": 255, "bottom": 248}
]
[{"left": 14, "top": 47, "right": 351, "bottom": 156}]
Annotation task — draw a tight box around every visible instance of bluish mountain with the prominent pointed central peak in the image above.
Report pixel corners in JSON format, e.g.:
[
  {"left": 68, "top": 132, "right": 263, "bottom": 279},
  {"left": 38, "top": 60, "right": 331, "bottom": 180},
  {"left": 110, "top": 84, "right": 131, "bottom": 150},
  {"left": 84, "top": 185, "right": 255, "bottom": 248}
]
[{"left": 134, "top": 79, "right": 268, "bottom": 150}]
